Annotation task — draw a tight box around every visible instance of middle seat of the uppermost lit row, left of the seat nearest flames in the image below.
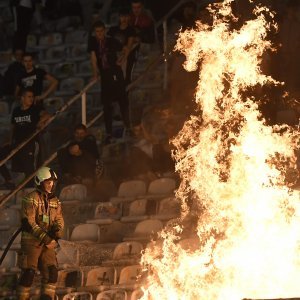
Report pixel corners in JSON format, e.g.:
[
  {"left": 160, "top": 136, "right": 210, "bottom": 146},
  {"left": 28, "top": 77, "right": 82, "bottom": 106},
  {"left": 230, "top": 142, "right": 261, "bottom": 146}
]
[{"left": 110, "top": 180, "right": 146, "bottom": 203}]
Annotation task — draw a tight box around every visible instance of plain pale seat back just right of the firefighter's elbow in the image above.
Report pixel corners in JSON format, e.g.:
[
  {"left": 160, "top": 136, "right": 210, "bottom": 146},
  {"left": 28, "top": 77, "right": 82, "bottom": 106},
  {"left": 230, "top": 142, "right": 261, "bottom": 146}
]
[{"left": 70, "top": 224, "right": 100, "bottom": 242}]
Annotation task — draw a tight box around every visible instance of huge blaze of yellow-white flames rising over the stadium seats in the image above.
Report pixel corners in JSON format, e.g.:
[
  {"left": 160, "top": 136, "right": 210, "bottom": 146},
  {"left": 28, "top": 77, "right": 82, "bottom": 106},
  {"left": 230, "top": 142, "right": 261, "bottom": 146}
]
[{"left": 142, "top": 0, "right": 300, "bottom": 300}]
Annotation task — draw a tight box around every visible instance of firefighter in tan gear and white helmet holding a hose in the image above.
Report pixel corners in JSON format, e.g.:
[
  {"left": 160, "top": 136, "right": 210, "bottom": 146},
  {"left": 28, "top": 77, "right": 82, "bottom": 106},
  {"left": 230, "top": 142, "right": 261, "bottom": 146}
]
[{"left": 17, "top": 167, "right": 64, "bottom": 300}]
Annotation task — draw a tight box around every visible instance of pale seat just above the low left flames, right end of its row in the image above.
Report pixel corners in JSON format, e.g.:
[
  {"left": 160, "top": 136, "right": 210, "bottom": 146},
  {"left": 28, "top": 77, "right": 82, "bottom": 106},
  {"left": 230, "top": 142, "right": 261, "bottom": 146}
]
[{"left": 123, "top": 220, "right": 163, "bottom": 241}]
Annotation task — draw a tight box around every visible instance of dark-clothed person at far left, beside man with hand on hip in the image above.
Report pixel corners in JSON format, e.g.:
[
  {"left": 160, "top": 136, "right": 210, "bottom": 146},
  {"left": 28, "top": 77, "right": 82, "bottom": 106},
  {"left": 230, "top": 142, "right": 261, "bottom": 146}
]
[{"left": 4, "top": 49, "right": 24, "bottom": 96}]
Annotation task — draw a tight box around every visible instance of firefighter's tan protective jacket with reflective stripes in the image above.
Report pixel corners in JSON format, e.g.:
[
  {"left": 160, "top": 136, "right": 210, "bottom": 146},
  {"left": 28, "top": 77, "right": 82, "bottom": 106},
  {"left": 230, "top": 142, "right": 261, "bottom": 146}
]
[{"left": 21, "top": 189, "right": 64, "bottom": 244}]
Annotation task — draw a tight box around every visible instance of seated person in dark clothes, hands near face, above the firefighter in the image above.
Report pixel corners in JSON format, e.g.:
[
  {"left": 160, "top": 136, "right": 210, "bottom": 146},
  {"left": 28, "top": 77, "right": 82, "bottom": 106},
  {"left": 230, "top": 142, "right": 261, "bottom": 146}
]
[{"left": 57, "top": 124, "right": 103, "bottom": 185}]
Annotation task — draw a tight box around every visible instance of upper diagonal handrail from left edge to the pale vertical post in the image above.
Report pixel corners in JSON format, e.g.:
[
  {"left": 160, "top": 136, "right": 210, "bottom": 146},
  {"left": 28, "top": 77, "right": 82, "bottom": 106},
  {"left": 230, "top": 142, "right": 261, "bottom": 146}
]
[{"left": 0, "top": 80, "right": 97, "bottom": 166}]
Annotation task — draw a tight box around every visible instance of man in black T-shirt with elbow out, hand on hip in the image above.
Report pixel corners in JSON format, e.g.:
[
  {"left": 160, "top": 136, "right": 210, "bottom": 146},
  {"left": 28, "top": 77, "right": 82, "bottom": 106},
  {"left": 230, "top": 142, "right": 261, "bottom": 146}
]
[{"left": 15, "top": 53, "right": 58, "bottom": 104}]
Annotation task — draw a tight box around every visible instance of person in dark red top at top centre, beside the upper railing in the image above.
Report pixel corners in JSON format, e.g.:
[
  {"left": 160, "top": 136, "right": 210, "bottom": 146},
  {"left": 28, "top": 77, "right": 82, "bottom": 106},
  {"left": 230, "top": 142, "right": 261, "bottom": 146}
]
[{"left": 130, "top": 0, "right": 155, "bottom": 44}]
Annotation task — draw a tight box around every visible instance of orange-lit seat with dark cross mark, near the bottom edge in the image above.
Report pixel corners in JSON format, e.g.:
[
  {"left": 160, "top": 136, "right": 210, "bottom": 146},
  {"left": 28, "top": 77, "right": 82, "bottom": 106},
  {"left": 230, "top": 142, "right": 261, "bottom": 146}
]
[{"left": 77, "top": 267, "right": 115, "bottom": 293}]
